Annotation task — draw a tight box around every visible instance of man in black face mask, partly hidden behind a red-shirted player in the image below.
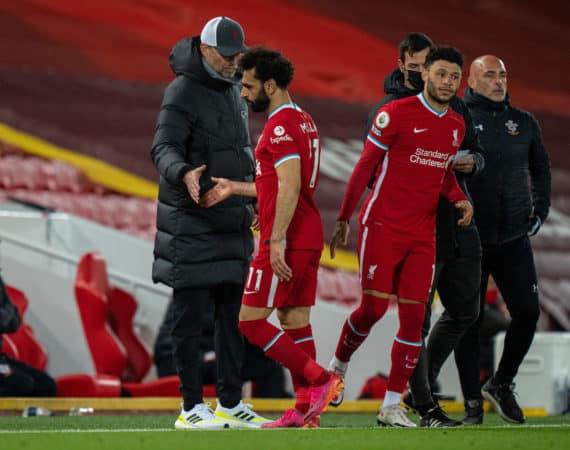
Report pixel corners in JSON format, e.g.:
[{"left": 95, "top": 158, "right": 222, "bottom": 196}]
[{"left": 358, "top": 33, "right": 484, "bottom": 427}]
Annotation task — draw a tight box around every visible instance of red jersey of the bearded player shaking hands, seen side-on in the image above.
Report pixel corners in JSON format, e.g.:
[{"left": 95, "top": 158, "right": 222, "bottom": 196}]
[{"left": 255, "top": 103, "right": 323, "bottom": 251}]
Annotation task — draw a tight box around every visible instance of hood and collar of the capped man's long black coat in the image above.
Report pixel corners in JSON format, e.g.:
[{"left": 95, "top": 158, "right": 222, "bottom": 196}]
[{"left": 169, "top": 36, "right": 235, "bottom": 88}]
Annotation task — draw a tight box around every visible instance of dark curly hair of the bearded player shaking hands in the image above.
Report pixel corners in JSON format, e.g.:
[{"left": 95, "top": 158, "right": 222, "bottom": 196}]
[{"left": 239, "top": 47, "right": 295, "bottom": 89}]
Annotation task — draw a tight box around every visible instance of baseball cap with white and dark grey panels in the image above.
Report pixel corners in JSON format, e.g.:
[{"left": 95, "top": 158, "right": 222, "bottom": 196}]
[{"left": 200, "top": 16, "right": 247, "bottom": 56}]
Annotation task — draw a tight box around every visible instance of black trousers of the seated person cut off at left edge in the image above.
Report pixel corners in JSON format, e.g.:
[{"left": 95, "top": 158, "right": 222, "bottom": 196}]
[{"left": 0, "top": 354, "right": 57, "bottom": 397}]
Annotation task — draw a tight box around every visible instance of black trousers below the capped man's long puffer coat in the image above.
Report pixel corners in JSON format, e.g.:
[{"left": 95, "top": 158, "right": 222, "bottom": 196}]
[{"left": 171, "top": 284, "right": 244, "bottom": 410}]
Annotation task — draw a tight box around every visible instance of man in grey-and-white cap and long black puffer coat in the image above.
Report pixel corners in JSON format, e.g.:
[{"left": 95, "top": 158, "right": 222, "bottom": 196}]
[{"left": 151, "top": 17, "right": 265, "bottom": 428}]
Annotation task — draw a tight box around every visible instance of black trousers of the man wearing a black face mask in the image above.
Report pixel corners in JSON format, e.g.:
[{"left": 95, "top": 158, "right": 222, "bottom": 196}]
[{"left": 409, "top": 252, "right": 481, "bottom": 406}]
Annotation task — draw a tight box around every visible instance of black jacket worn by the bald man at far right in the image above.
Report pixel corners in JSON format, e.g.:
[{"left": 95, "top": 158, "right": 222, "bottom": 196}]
[{"left": 464, "top": 88, "right": 551, "bottom": 245}]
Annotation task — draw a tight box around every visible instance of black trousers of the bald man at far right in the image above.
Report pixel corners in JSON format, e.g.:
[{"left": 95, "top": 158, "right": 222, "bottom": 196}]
[{"left": 455, "top": 236, "right": 540, "bottom": 400}]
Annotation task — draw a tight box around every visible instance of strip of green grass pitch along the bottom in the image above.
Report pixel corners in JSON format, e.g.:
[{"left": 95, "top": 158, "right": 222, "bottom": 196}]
[{"left": 0, "top": 413, "right": 570, "bottom": 450}]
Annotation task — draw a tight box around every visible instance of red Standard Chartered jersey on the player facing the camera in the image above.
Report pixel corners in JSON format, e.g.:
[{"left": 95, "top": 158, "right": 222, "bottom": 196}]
[{"left": 339, "top": 93, "right": 466, "bottom": 240}]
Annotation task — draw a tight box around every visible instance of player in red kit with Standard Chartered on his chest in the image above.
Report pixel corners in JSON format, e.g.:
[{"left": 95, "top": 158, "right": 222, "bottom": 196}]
[{"left": 330, "top": 47, "right": 473, "bottom": 427}]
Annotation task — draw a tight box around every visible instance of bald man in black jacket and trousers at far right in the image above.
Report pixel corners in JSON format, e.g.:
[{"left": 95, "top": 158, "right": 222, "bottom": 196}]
[{"left": 455, "top": 55, "right": 550, "bottom": 423}]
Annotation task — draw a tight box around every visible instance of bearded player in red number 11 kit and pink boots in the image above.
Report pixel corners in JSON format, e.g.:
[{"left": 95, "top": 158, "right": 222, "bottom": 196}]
[{"left": 200, "top": 48, "right": 343, "bottom": 428}]
